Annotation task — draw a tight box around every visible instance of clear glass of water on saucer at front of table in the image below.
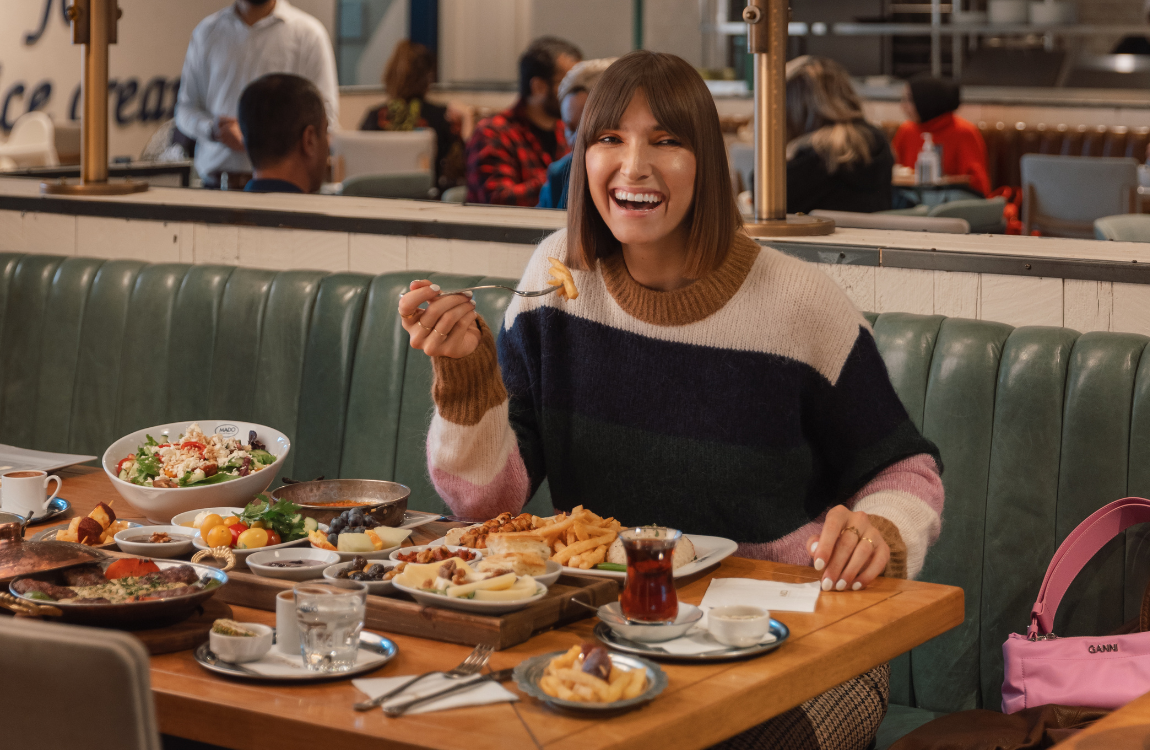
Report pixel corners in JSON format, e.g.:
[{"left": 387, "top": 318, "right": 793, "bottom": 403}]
[{"left": 293, "top": 581, "right": 367, "bottom": 673}]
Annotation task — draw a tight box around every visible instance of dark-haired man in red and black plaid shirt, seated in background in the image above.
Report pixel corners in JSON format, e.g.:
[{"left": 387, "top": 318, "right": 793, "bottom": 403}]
[{"left": 467, "top": 37, "right": 583, "bottom": 206}]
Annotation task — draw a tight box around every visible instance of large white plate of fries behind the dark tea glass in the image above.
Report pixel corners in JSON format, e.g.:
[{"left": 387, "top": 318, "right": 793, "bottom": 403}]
[{"left": 431, "top": 505, "right": 738, "bottom": 580}]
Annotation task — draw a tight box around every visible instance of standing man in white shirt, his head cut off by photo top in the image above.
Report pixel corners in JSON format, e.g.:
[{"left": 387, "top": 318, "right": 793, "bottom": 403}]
[{"left": 176, "top": 0, "right": 339, "bottom": 190}]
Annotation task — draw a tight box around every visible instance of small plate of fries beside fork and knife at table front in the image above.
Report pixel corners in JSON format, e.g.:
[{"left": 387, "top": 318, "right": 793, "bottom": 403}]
[{"left": 515, "top": 645, "right": 667, "bottom": 712}]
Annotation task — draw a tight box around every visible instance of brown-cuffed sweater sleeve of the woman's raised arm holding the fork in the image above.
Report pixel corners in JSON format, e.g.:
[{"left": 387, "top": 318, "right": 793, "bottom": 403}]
[{"left": 427, "top": 317, "right": 531, "bottom": 519}]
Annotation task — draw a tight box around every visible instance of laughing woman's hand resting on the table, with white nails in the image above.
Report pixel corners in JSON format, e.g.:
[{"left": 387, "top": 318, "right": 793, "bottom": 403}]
[{"left": 806, "top": 505, "right": 890, "bottom": 591}]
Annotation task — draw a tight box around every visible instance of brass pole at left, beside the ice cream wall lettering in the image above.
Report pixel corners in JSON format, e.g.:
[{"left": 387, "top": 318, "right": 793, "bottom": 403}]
[{"left": 40, "top": 0, "right": 147, "bottom": 196}]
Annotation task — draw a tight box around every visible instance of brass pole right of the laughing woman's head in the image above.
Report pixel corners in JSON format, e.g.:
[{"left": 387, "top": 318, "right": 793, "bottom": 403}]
[{"left": 743, "top": 0, "right": 835, "bottom": 237}]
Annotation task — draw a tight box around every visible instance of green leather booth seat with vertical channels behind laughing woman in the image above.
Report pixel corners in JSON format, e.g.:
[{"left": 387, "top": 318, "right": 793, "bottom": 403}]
[{"left": 0, "top": 254, "right": 1150, "bottom": 747}]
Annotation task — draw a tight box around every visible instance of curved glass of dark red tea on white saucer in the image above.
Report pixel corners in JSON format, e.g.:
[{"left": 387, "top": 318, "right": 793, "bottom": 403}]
[{"left": 619, "top": 526, "right": 682, "bottom": 622}]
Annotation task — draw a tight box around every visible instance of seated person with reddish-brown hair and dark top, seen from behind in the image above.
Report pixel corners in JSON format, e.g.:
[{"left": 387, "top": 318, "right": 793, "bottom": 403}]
[{"left": 360, "top": 39, "right": 463, "bottom": 190}]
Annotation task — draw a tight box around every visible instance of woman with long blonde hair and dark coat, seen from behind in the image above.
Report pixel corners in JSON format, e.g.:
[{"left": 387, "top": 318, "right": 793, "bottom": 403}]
[{"left": 787, "top": 56, "right": 895, "bottom": 213}]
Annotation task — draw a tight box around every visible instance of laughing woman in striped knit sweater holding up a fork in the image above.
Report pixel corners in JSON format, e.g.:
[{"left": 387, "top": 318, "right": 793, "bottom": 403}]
[{"left": 399, "top": 51, "right": 943, "bottom": 749}]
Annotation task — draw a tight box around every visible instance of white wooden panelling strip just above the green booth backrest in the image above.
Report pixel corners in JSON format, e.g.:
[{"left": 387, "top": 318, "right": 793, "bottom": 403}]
[{"left": 11, "top": 211, "right": 1150, "bottom": 335}]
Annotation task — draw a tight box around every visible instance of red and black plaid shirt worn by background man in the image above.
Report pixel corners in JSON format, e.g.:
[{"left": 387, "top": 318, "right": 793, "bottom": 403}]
[{"left": 467, "top": 104, "right": 567, "bottom": 207}]
